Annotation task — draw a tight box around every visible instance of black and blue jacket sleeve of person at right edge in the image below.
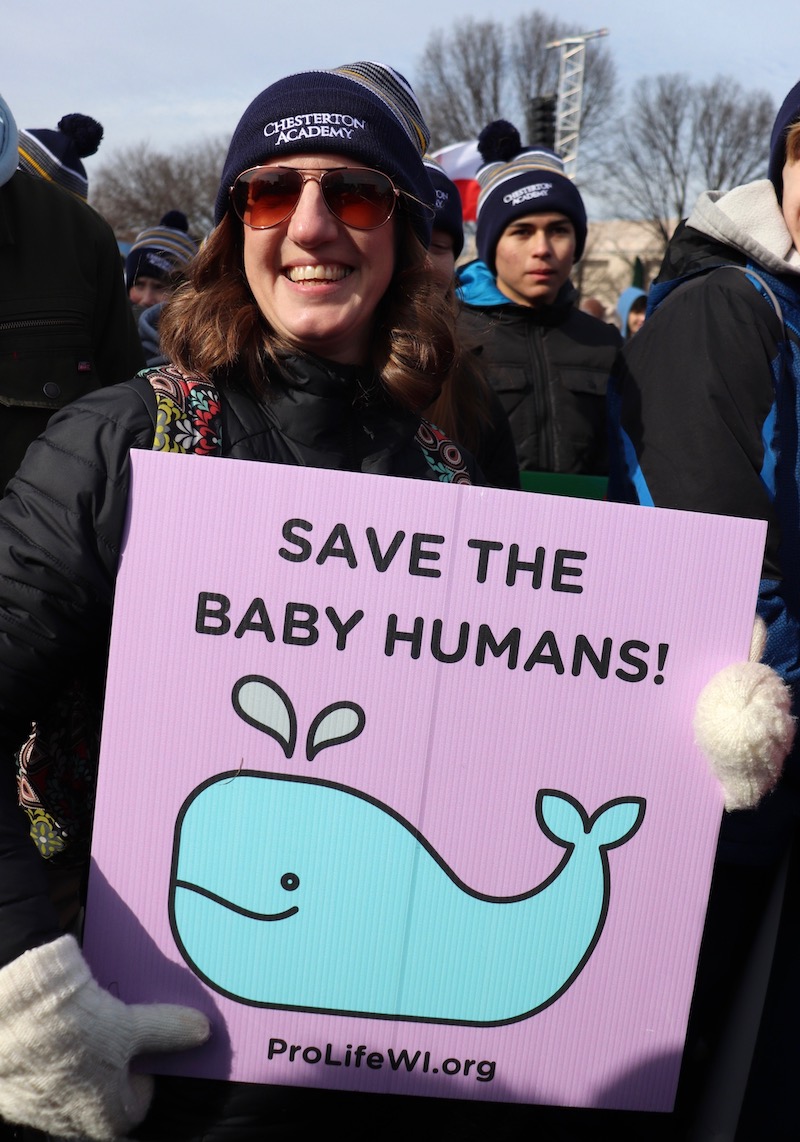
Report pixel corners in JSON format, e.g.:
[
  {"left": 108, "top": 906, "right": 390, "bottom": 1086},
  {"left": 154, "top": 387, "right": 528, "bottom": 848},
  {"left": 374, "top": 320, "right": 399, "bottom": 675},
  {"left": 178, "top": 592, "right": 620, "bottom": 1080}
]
[{"left": 609, "top": 264, "right": 800, "bottom": 813}]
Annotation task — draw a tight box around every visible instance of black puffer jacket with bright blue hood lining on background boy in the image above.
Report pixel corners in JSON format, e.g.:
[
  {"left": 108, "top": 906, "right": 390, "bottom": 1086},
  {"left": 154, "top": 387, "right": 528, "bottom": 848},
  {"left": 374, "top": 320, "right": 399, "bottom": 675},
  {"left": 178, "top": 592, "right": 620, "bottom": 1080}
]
[{"left": 459, "top": 263, "right": 622, "bottom": 475}]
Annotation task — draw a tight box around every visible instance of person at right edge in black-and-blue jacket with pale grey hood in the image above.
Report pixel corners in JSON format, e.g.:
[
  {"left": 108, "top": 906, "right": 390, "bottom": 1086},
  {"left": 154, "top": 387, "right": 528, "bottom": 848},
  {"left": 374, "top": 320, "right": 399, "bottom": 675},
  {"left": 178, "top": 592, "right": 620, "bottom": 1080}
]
[{"left": 609, "top": 75, "right": 800, "bottom": 1140}]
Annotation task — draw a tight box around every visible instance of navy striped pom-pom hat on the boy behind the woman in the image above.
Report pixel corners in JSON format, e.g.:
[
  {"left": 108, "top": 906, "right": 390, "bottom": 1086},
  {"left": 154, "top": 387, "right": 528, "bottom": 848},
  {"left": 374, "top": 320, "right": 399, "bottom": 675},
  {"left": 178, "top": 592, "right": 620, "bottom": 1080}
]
[{"left": 476, "top": 119, "right": 587, "bottom": 273}]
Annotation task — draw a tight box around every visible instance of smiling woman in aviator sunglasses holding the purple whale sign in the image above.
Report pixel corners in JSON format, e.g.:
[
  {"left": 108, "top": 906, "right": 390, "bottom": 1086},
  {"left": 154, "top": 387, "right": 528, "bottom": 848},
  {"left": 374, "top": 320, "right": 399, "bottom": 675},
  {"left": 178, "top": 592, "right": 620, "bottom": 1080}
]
[{"left": 0, "top": 64, "right": 789, "bottom": 1142}]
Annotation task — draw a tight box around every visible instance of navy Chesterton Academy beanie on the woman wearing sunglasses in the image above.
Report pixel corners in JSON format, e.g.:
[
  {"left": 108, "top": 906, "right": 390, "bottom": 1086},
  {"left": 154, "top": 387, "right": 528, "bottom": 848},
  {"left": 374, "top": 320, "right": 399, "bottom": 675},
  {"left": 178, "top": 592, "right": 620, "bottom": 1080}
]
[{"left": 215, "top": 63, "right": 434, "bottom": 246}]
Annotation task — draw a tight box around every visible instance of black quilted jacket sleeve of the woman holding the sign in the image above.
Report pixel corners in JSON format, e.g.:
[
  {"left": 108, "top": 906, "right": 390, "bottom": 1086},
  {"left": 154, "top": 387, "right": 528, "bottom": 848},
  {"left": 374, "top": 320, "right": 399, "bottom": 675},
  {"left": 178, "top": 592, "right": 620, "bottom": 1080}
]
[{"left": 0, "top": 385, "right": 153, "bottom": 964}]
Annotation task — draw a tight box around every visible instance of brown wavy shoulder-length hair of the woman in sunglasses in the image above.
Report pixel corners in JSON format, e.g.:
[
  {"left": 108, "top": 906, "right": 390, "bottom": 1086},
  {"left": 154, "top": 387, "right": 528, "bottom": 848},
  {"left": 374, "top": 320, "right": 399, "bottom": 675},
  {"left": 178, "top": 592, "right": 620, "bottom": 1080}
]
[{"left": 160, "top": 206, "right": 459, "bottom": 412}]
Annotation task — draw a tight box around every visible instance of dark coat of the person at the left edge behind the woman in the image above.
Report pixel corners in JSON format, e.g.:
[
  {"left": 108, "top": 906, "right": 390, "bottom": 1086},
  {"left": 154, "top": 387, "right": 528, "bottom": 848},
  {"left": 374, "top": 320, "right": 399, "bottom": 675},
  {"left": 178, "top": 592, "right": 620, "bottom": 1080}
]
[{"left": 0, "top": 170, "right": 145, "bottom": 491}]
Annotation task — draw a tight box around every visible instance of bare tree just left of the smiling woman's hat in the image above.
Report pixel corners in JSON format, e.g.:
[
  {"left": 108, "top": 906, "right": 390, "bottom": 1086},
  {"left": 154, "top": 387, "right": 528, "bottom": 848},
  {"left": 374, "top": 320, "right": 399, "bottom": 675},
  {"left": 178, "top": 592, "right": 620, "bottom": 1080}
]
[{"left": 91, "top": 138, "right": 227, "bottom": 242}]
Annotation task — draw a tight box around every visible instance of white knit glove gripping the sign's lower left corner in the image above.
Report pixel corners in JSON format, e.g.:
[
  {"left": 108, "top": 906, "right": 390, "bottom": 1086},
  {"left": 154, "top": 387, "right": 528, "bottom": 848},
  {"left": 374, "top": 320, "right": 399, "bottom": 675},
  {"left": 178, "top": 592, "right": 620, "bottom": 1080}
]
[{"left": 0, "top": 935, "right": 210, "bottom": 1140}]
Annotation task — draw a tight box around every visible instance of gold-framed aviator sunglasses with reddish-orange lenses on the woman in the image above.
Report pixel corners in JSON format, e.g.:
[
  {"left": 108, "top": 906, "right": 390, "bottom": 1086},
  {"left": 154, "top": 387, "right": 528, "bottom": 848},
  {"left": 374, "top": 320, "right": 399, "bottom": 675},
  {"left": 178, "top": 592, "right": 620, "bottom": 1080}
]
[{"left": 229, "top": 167, "right": 433, "bottom": 230}]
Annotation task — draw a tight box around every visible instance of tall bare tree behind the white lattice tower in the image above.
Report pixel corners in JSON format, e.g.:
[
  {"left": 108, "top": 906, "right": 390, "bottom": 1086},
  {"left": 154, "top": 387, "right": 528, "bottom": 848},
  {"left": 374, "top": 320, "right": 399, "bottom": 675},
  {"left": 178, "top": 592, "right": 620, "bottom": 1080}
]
[{"left": 414, "top": 11, "right": 616, "bottom": 154}]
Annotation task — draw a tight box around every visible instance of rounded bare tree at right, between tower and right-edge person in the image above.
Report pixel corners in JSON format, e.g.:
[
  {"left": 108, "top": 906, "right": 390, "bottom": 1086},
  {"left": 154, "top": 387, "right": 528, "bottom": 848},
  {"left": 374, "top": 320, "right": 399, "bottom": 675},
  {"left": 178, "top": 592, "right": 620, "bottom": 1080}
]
[{"left": 605, "top": 74, "right": 775, "bottom": 256}]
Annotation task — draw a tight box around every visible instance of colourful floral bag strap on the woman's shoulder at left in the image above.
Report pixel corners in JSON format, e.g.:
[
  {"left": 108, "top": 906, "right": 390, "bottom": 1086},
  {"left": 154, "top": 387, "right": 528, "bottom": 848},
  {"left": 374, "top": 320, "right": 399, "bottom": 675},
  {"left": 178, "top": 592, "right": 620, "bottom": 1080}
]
[{"left": 140, "top": 365, "right": 223, "bottom": 456}]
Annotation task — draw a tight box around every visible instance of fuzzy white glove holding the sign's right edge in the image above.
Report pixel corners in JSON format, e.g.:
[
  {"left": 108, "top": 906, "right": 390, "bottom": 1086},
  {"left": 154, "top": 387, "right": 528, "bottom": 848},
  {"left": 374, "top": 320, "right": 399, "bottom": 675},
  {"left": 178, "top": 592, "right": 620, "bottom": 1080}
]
[{"left": 694, "top": 618, "right": 794, "bottom": 812}]
